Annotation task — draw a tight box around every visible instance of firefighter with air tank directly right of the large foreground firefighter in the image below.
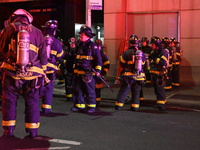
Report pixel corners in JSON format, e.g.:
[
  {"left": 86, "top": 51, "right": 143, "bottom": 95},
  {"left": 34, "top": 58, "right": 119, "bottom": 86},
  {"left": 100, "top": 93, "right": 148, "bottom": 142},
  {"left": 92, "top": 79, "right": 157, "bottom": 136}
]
[{"left": 40, "top": 20, "right": 63, "bottom": 113}]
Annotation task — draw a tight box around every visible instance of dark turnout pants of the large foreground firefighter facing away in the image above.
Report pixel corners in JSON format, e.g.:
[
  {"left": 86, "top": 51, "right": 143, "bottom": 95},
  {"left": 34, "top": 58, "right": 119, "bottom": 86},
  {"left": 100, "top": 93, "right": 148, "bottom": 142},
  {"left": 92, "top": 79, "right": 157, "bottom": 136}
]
[{"left": 2, "top": 74, "right": 40, "bottom": 132}]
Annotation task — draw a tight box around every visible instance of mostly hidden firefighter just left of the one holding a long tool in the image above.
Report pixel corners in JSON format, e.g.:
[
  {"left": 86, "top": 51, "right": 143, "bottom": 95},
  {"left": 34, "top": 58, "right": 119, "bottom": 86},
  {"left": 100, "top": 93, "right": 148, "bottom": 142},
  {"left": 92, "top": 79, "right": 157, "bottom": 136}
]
[{"left": 64, "top": 37, "right": 76, "bottom": 101}]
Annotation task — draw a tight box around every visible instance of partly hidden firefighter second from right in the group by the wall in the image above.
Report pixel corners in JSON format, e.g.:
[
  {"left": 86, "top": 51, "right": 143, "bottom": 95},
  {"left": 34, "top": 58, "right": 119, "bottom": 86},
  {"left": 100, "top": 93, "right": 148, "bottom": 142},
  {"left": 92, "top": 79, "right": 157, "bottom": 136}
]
[{"left": 161, "top": 37, "right": 172, "bottom": 90}]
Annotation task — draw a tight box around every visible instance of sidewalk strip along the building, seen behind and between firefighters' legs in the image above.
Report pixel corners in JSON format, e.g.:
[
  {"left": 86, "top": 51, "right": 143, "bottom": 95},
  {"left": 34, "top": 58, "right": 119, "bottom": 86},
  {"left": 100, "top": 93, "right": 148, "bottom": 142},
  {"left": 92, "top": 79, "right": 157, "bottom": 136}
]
[{"left": 54, "top": 81, "right": 200, "bottom": 111}]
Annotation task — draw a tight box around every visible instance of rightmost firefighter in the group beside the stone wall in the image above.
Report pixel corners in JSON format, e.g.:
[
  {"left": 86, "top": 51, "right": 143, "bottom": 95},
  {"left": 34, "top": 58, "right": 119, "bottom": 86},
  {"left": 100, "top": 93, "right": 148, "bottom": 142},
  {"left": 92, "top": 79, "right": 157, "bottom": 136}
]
[{"left": 170, "top": 37, "right": 183, "bottom": 87}]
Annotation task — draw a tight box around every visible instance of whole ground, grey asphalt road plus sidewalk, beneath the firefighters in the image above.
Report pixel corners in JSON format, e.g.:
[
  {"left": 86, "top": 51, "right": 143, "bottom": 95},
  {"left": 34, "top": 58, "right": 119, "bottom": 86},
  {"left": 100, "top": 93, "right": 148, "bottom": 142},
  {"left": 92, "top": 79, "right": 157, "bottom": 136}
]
[{"left": 0, "top": 81, "right": 200, "bottom": 150}]
